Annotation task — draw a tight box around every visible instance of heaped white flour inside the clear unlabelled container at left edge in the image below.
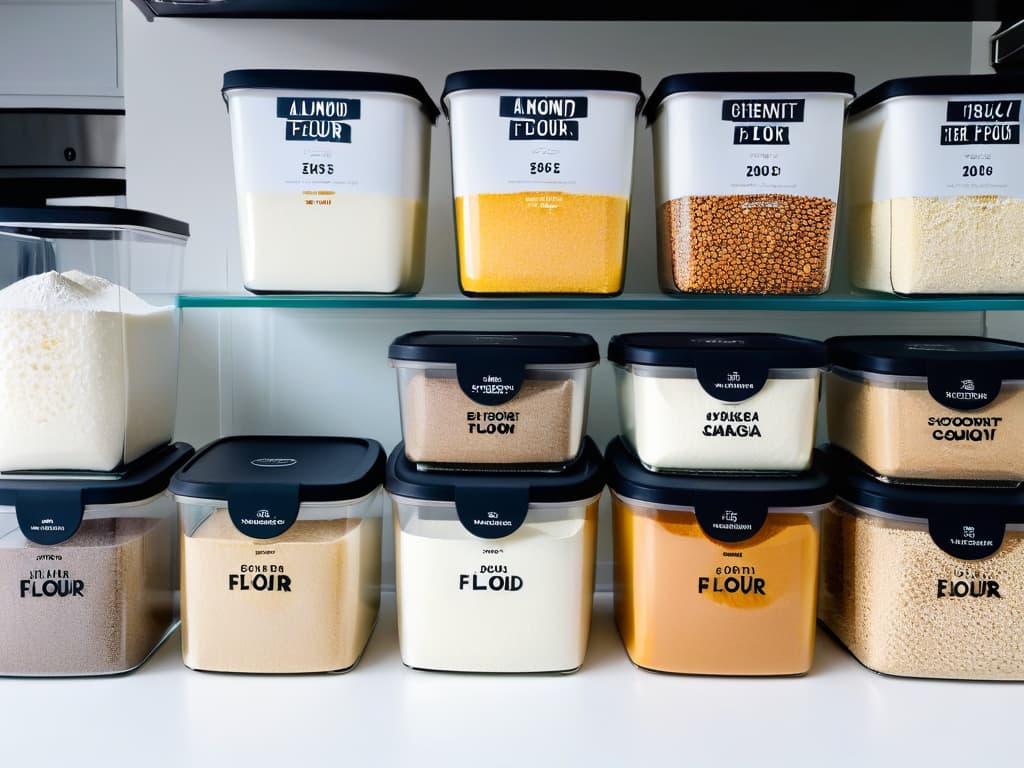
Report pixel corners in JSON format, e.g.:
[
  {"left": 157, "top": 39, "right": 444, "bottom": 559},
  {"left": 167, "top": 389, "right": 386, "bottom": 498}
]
[{"left": 0, "top": 271, "right": 178, "bottom": 472}]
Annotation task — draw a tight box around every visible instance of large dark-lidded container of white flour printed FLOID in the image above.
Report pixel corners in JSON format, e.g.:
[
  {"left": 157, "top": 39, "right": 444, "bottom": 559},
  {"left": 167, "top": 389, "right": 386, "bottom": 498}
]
[{"left": 387, "top": 438, "right": 604, "bottom": 673}]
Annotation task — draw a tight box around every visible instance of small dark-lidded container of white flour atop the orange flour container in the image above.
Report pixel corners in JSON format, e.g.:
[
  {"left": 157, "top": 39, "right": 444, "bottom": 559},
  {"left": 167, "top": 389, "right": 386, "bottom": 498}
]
[{"left": 608, "top": 333, "right": 826, "bottom": 472}]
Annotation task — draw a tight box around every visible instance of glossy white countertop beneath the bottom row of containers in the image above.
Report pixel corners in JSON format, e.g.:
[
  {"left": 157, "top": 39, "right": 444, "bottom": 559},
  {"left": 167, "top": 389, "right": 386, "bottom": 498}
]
[{"left": 0, "top": 593, "right": 1024, "bottom": 768}]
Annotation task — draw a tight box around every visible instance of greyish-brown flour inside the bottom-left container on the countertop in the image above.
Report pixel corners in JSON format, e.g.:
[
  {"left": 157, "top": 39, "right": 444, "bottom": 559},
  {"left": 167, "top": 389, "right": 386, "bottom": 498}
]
[{"left": 0, "top": 517, "right": 177, "bottom": 676}]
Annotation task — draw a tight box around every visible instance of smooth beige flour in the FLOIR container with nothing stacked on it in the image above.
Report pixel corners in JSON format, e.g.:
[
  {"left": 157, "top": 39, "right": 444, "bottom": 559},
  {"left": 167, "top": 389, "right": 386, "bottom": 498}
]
[{"left": 181, "top": 509, "right": 382, "bottom": 673}]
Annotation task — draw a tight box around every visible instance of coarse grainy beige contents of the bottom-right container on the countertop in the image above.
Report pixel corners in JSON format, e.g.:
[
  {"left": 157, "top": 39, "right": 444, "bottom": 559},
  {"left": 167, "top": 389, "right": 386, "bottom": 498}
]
[{"left": 819, "top": 501, "right": 1024, "bottom": 680}]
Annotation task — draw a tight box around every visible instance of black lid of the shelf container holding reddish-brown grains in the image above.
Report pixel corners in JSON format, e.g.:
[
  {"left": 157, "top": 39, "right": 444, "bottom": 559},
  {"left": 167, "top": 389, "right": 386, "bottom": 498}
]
[{"left": 643, "top": 72, "right": 856, "bottom": 125}]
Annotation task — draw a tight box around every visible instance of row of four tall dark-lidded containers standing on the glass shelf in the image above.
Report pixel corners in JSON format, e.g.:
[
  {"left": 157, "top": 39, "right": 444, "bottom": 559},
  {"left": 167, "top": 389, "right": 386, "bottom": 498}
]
[{"left": 222, "top": 70, "right": 1024, "bottom": 296}]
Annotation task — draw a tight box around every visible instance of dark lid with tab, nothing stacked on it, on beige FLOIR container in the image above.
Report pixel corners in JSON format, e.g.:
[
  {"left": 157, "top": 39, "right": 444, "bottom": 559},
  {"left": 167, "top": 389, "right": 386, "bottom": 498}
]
[{"left": 170, "top": 435, "right": 386, "bottom": 539}]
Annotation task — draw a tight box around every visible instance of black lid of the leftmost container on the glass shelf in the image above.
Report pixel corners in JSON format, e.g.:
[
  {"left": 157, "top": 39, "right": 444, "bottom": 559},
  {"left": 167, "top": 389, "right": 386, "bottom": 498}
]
[{"left": 220, "top": 70, "right": 440, "bottom": 123}]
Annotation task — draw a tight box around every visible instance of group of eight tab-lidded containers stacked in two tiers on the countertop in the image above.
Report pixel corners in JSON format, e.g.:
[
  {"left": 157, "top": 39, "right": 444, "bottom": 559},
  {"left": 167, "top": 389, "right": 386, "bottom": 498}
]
[{"left": 6, "top": 332, "right": 1024, "bottom": 680}]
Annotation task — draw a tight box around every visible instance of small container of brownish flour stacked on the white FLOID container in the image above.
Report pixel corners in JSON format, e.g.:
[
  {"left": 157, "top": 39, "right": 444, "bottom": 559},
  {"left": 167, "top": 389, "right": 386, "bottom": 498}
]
[{"left": 388, "top": 331, "right": 600, "bottom": 469}]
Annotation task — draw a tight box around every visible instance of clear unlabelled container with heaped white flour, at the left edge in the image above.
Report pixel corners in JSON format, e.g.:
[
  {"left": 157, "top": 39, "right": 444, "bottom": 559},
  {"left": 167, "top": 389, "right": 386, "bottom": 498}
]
[{"left": 0, "top": 207, "right": 188, "bottom": 479}]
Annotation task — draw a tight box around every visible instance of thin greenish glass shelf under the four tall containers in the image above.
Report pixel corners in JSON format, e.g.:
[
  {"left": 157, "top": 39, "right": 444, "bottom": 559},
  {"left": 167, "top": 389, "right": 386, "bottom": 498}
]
[{"left": 178, "top": 293, "right": 1024, "bottom": 312}]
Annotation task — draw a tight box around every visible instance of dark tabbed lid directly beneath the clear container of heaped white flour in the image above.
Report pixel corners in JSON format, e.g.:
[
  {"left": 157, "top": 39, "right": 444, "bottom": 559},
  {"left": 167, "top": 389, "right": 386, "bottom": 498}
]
[{"left": 0, "top": 442, "right": 196, "bottom": 545}]
